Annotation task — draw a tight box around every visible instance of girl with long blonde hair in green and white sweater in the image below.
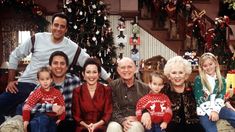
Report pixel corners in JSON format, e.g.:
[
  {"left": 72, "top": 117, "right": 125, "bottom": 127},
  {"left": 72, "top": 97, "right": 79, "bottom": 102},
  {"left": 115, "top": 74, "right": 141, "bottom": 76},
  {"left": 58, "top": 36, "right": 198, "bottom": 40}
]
[{"left": 194, "top": 53, "right": 235, "bottom": 132}]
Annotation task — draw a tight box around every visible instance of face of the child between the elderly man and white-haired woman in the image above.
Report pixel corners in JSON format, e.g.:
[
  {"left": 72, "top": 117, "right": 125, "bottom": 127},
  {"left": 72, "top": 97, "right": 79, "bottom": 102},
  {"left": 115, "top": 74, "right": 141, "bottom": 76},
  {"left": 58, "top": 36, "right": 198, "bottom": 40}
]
[{"left": 149, "top": 76, "right": 164, "bottom": 93}]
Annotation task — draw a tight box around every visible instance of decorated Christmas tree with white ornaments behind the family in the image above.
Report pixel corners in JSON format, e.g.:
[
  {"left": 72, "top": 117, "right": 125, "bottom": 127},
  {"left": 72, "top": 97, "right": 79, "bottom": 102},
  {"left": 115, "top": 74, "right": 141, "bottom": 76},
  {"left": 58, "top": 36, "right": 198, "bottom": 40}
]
[{"left": 64, "top": 0, "right": 117, "bottom": 79}]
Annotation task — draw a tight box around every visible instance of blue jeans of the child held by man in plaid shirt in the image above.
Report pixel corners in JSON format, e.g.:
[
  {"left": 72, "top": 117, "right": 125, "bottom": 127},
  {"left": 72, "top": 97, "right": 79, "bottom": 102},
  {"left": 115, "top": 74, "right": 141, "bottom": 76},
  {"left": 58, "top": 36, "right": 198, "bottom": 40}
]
[{"left": 28, "top": 113, "right": 57, "bottom": 132}]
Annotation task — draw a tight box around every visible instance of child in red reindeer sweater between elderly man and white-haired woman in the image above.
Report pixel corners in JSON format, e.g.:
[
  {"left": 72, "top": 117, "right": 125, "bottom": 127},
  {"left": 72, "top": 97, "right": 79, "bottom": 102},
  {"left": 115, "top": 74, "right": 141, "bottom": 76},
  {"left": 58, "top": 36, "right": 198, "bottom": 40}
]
[{"left": 136, "top": 72, "right": 172, "bottom": 132}]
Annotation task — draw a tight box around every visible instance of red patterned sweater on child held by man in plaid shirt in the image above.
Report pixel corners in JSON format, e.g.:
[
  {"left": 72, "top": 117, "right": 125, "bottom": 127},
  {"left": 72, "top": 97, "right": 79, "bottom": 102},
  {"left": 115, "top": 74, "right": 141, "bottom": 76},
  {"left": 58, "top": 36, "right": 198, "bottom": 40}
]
[{"left": 23, "top": 87, "right": 65, "bottom": 121}]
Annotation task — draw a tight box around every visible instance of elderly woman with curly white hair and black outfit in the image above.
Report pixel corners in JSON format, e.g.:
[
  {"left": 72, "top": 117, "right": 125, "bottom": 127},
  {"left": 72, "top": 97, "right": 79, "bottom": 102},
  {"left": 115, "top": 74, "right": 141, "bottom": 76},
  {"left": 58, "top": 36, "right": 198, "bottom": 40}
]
[{"left": 162, "top": 56, "right": 204, "bottom": 132}]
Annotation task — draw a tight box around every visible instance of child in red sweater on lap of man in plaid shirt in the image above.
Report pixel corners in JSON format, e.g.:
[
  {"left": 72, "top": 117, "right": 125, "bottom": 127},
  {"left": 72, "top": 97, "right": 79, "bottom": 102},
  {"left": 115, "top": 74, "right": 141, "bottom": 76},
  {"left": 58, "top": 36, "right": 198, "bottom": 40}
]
[{"left": 23, "top": 67, "right": 65, "bottom": 132}]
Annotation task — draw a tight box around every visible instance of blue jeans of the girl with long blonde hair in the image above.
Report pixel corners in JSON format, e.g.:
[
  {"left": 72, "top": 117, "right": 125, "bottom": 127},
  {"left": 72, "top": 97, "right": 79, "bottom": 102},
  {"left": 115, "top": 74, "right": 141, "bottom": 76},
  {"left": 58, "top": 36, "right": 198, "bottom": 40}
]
[{"left": 199, "top": 107, "right": 235, "bottom": 132}]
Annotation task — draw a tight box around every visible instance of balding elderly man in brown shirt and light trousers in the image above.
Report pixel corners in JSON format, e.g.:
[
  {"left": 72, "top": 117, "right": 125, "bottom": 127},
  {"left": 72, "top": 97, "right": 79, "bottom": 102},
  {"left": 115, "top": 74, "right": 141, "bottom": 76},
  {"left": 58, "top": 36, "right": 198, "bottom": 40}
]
[{"left": 107, "top": 57, "right": 151, "bottom": 132}]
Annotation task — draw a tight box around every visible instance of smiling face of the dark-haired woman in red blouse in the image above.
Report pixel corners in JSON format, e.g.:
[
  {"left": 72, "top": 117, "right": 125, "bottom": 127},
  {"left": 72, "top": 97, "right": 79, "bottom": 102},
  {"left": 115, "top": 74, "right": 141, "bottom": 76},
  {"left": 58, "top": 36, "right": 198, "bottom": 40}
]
[{"left": 82, "top": 64, "right": 100, "bottom": 86}]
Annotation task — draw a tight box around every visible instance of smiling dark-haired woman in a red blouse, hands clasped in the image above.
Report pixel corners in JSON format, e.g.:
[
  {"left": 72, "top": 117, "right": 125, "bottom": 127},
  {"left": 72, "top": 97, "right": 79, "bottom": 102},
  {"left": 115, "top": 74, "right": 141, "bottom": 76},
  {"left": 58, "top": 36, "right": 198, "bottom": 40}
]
[{"left": 72, "top": 58, "right": 112, "bottom": 132}]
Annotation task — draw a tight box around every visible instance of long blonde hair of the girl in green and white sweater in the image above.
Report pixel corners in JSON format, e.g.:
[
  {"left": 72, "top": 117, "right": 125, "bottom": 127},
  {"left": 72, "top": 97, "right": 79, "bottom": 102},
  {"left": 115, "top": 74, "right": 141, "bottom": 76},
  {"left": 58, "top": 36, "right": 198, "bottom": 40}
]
[{"left": 199, "top": 53, "right": 223, "bottom": 91}]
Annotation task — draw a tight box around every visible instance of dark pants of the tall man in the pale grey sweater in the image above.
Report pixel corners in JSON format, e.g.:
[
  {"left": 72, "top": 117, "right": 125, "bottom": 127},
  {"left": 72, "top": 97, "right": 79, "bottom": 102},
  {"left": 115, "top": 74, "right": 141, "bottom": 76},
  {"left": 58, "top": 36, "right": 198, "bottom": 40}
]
[{"left": 0, "top": 82, "right": 36, "bottom": 124}]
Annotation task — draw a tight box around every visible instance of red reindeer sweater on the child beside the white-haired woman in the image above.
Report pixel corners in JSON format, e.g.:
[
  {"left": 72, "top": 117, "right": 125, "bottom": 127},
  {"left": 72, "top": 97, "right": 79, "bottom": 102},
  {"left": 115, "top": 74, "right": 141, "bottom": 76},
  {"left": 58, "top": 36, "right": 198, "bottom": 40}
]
[{"left": 136, "top": 93, "right": 172, "bottom": 123}]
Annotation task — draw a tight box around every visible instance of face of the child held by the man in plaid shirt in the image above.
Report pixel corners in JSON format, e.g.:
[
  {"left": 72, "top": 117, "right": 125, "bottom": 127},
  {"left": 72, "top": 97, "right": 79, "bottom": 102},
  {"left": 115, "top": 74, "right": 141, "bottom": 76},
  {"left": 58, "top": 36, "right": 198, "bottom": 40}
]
[{"left": 38, "top": 71, "right": 52, "bottom": 91}]
